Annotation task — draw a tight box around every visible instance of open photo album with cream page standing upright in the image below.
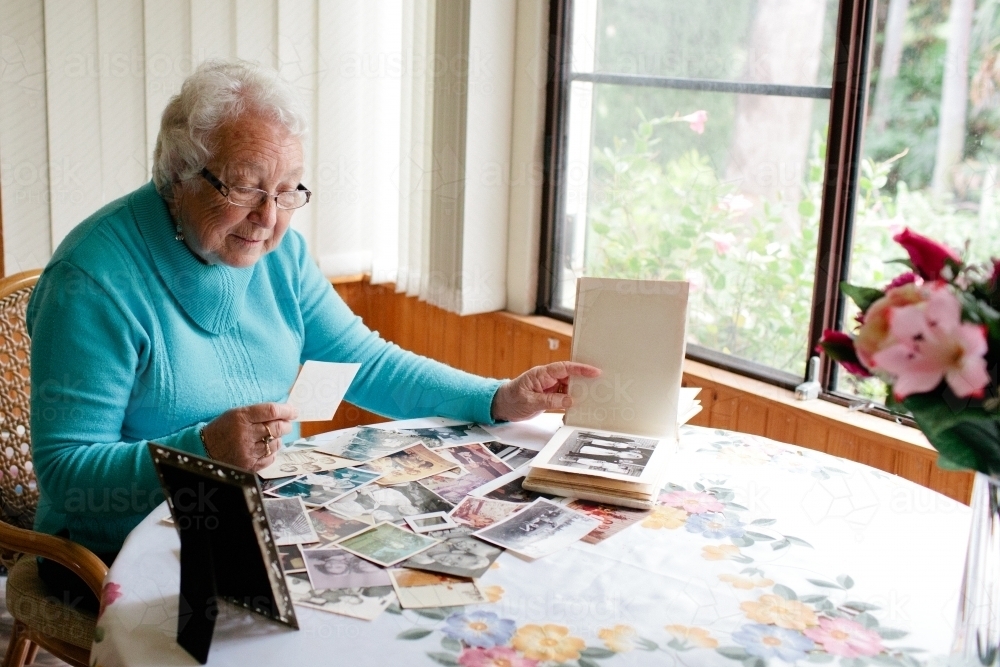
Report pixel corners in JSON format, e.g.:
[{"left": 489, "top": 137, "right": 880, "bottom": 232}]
[{"left": 523, "top": 278, "right": 701, "bottom": 509}]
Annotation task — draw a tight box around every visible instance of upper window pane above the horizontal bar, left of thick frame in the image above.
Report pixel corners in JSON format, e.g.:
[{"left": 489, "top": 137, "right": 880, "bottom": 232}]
[{"left": 595, "top": 0, "right": 837, "bottom": 86}]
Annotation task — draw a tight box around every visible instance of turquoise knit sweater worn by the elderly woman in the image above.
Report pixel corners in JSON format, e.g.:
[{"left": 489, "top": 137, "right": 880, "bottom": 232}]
[{"left": 27, "top": 183, "right": 500, "bottom": 552}]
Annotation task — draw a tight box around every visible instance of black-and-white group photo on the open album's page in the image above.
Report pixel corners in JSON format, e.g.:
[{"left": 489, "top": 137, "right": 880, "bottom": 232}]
[{"left": 531, "top": 426, "right": 668, "bottom": 484}]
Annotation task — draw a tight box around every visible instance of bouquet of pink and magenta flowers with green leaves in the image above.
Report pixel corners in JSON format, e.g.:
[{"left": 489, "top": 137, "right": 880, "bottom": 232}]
[{"left": 817, "top": 229, "right": 1000, "bottom": 476}]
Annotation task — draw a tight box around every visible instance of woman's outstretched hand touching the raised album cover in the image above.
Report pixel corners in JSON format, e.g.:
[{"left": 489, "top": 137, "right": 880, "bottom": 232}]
[{"left": 492, "top": 361, "right": 601, "bottom": 421}]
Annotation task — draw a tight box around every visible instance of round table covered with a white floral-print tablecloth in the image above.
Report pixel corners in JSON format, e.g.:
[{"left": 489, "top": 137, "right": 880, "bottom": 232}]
[{"left": 92, "top": 426, "right": 970, "bottom": 667}]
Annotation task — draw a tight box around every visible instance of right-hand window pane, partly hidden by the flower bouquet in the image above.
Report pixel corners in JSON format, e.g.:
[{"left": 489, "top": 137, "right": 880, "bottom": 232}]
[{"left": 837, "top": 0, "right": 1000, "bottom": 401}]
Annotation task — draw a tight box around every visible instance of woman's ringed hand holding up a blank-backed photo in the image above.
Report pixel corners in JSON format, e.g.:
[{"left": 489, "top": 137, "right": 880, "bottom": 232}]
[{"left": 201, "top": 403, "right": 298, "bottom": 472}]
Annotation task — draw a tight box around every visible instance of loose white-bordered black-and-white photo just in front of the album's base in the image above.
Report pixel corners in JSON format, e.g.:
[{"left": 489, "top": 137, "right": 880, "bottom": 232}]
[{"left": 475, "top": 498, "right": 601, "bottom": 558}]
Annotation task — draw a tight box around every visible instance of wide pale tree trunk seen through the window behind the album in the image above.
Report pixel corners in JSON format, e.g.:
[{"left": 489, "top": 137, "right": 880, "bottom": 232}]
[{"left": 727, "top": 0, "right": 826, "bottom": 220}]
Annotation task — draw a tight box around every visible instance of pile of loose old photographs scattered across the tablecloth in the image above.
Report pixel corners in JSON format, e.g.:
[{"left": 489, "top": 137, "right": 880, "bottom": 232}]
[{"left": 258, "top": 418, "right": 648, "bottom": 620}]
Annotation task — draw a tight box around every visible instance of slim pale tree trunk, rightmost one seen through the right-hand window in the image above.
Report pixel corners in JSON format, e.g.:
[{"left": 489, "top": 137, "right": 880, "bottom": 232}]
[{"left": 931, "top": 0, "right": 976, "bottom": 196}]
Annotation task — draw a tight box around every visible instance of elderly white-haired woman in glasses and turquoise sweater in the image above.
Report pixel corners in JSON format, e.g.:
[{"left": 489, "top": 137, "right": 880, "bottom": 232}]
[{"left": 28, "top": 61, "right": 597, "bottom": 608}]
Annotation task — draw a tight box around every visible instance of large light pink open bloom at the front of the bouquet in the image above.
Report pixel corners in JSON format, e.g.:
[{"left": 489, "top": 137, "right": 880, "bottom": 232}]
[{"left": 872, "top": 283, "right": 990, "bottom": 400}]
